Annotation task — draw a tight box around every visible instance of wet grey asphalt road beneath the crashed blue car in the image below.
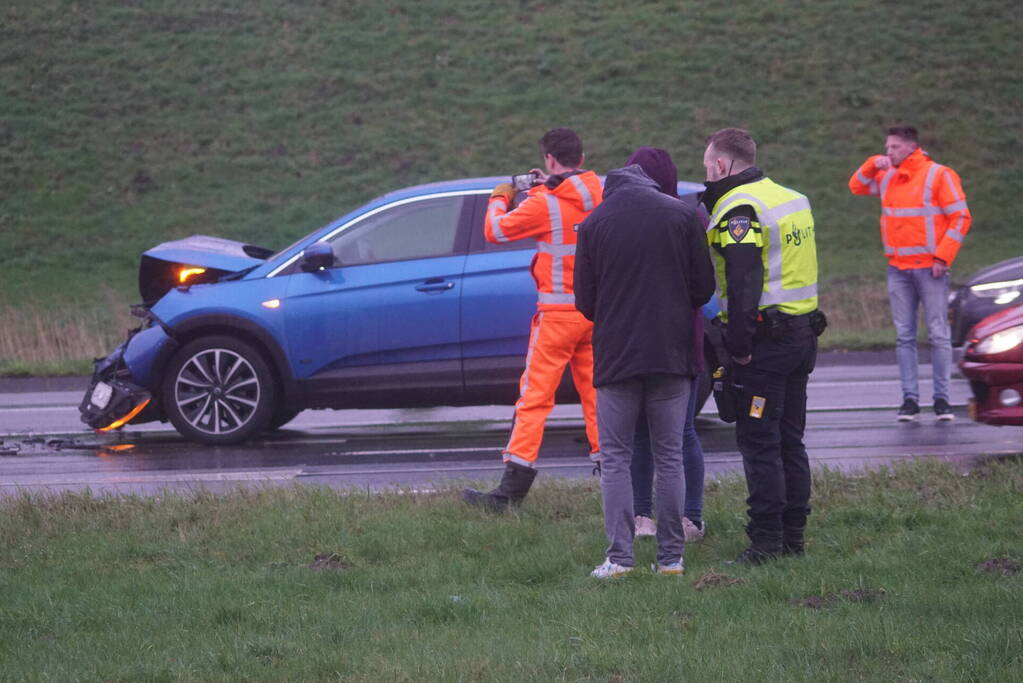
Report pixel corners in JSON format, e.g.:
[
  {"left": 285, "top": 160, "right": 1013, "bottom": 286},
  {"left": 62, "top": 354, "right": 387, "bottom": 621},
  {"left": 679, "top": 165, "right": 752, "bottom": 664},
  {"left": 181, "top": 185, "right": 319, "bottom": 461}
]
[{"left": 0, "top": 359, "right": 1023, "bottom": 495}]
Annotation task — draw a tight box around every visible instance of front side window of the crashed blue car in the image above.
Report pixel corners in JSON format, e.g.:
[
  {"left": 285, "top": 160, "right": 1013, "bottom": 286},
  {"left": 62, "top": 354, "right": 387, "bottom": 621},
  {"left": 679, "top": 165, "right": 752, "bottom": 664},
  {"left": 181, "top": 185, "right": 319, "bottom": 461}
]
[{"left": 329, "top": 196, "right": 464, "bottom": 266}]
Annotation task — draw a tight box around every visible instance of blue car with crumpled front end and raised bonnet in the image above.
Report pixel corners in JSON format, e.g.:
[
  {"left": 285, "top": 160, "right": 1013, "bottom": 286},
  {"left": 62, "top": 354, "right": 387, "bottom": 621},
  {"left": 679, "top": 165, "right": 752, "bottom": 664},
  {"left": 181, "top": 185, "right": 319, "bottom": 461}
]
[{"left": 80, "top": 178, "right": 702, "bottom": 444}]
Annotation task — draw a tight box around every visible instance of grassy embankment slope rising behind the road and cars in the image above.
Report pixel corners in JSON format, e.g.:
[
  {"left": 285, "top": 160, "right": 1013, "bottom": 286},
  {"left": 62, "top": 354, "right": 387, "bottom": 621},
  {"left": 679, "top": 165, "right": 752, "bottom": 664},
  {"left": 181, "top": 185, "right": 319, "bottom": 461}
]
[{"left": 0, "top": 0, "right": 1023, "bottom": 374}]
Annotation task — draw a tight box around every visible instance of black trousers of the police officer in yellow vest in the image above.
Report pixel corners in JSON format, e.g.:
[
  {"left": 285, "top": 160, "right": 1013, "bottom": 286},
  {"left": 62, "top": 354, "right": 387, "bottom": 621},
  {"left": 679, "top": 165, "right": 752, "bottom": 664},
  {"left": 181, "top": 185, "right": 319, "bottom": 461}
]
[{"left": 733, "top": 329, "right": 817, "bottom": 531}]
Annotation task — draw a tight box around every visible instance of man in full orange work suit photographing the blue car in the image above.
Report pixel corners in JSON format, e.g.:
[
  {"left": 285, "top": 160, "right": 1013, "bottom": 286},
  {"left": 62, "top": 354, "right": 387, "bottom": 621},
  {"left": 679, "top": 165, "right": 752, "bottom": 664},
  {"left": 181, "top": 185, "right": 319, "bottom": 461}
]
[{"left": 462, "top": 128, "right": 603, "bottom": 510}]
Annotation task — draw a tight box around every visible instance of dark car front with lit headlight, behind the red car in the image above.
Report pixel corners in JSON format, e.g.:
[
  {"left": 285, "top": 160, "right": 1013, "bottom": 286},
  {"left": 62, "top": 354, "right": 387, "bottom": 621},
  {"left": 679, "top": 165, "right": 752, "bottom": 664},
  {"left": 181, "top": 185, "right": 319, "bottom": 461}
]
[{"left": 948, "top": 257, "right": 1023, "bottom": 347}]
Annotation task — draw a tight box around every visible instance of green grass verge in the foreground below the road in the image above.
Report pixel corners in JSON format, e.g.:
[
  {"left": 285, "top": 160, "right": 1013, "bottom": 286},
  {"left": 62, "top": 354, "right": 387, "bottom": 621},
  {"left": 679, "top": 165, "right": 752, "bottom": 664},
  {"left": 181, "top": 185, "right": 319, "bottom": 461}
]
[{"left": 0, "top": 459, "right": 1023, "bottom": 681}]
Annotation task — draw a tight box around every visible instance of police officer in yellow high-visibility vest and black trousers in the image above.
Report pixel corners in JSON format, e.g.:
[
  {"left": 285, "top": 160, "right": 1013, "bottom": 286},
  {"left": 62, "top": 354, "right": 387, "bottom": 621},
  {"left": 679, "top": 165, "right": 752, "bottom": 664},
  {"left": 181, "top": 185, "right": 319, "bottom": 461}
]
[{"left": 703, "top": 128, "right": 826, "bottom": 564}]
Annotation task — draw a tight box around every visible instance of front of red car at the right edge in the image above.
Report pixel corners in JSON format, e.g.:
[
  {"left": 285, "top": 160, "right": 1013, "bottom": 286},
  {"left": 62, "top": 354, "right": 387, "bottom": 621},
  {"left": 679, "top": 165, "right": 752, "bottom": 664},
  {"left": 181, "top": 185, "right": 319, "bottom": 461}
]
[{"left": 960, "top": 306, "right": 1023, "bottom": 424}]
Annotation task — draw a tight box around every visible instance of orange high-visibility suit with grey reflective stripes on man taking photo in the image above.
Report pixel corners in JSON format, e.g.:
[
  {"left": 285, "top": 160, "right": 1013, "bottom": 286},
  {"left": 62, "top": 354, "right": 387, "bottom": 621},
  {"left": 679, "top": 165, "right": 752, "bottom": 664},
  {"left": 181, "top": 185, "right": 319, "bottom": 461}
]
[{"left": 484, "top": 171, "right": 604, "bottom": 467}]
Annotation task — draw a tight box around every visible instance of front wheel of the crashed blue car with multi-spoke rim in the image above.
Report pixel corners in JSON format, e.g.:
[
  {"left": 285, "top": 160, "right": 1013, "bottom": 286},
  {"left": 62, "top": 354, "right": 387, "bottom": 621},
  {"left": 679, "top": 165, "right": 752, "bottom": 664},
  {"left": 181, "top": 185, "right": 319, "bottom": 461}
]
[{"left": 162, "top": 335, "right": 277, "bottom": 445}]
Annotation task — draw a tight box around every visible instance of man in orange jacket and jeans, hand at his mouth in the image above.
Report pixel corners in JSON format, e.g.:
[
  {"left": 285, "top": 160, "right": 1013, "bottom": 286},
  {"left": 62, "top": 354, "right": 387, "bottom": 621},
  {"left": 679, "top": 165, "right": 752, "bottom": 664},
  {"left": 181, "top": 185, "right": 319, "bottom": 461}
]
[{"left": 849, "top": 126, "right": 972, "bottom": 421}]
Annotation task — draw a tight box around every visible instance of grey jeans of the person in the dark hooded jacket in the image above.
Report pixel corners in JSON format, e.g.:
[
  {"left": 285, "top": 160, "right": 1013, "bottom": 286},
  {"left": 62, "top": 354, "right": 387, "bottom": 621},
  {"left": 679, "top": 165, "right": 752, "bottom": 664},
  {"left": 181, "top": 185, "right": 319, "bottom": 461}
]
[{"left": 596, "top": 374, "right": 692, "bottom": 566}]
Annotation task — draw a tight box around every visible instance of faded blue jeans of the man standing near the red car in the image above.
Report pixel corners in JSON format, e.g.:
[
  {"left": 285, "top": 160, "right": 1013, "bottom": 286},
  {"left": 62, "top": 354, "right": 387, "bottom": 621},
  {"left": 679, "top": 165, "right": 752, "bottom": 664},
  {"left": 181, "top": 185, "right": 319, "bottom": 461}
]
[{"left": 888, "top": 266, "right": 952, "bottom": 402}]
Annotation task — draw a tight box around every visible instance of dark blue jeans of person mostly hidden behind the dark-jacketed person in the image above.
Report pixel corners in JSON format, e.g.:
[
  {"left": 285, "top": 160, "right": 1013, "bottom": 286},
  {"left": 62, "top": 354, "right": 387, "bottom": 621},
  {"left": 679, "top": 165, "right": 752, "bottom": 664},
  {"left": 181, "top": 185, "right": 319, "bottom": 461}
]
[{"left": 632, "top": 381, "right": 704, "bottom": 526}]
